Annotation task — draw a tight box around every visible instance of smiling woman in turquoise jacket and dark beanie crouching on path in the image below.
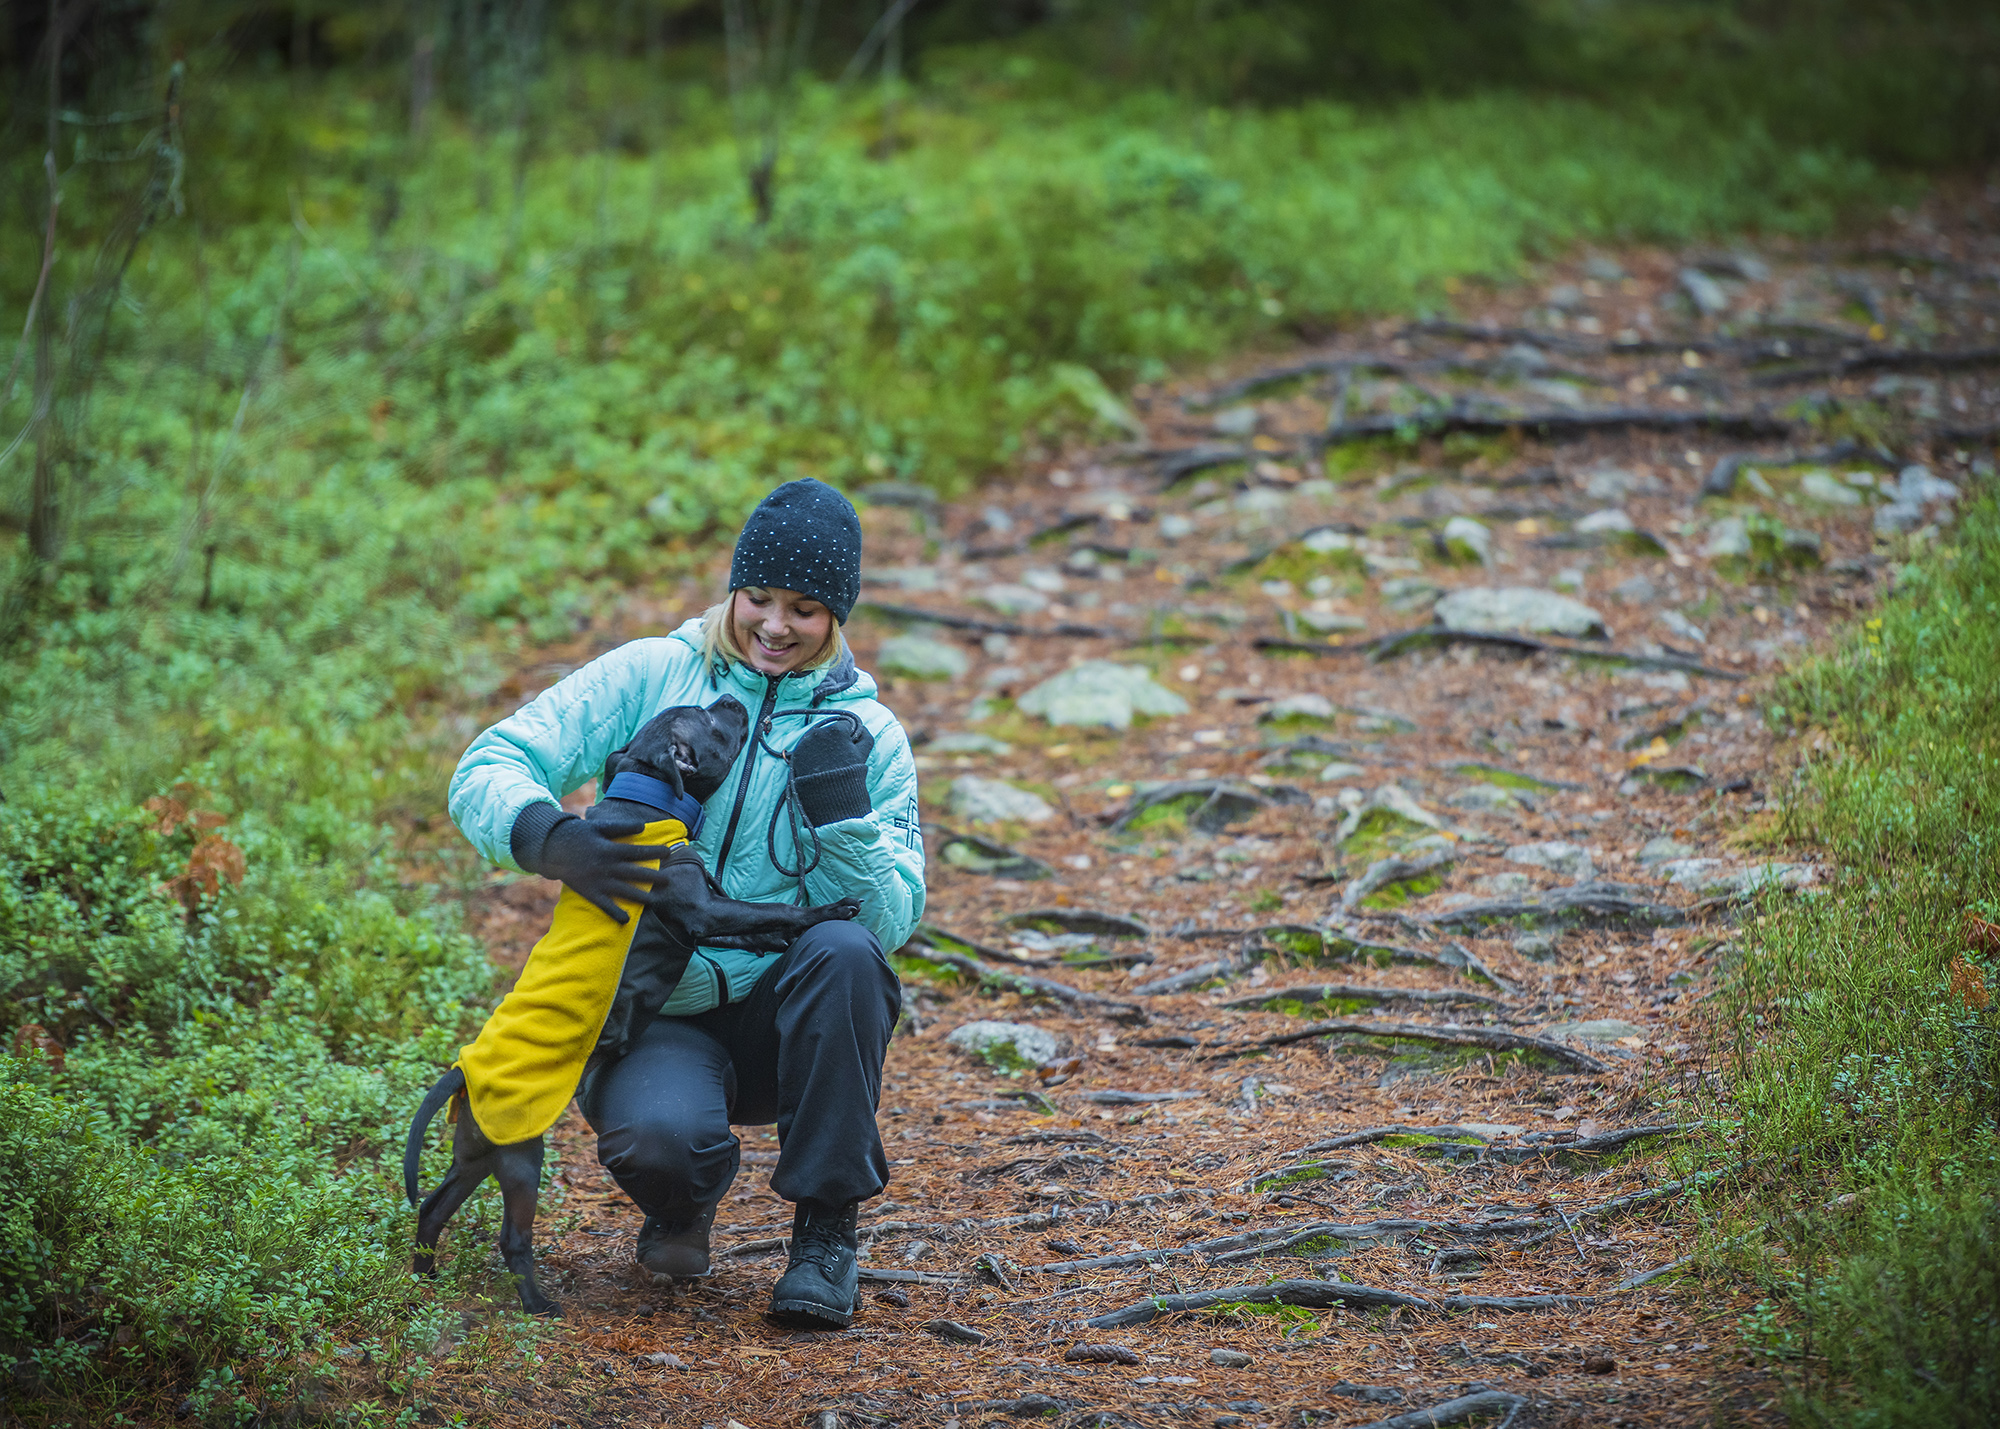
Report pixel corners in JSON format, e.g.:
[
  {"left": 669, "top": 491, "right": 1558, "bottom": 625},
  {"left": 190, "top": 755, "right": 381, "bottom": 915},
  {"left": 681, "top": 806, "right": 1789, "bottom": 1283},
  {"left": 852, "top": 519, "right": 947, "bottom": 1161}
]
[{"left": 450, "top": 480, "right": 924, "bottom": 1325}]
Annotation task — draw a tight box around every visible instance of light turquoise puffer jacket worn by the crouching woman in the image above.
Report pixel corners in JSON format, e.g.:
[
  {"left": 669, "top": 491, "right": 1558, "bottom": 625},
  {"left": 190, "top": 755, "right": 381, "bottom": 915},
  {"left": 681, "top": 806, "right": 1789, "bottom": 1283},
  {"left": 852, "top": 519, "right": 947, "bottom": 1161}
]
[{"left": 450, "top": 618, "right": 924, "bottom": 1017}]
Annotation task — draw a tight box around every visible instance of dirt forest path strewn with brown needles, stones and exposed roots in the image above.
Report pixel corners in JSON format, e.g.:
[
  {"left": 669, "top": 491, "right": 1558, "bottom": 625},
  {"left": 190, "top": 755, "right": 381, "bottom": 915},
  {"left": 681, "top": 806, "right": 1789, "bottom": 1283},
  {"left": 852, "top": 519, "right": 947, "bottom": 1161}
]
[{"left": 414, "top": 196, "right": 2000, "bottom": 1429}]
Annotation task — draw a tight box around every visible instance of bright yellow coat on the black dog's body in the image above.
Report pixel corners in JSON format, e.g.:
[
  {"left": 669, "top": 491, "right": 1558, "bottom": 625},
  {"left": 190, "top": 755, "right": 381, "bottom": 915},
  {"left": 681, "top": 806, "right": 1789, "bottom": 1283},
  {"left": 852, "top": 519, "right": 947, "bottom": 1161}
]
[{"left": 458, "top": 819, "right": 692, "bottom": 1145}]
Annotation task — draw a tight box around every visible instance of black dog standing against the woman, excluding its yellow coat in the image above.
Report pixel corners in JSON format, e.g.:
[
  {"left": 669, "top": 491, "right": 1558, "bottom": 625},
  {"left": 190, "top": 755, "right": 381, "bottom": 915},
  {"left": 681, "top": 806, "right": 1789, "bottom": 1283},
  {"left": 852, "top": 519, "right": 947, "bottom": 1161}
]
[{"left": 402, "top": 696, "right": 862, "bottom": 1315}]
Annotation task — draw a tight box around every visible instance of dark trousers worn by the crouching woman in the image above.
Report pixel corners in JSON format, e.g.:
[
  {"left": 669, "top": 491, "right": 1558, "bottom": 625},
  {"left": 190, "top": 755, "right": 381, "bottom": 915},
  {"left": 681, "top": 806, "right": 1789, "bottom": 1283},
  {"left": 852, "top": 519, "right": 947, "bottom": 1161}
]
[{"left": 580, "top": 923, "right": 902, "bottom": 1219}]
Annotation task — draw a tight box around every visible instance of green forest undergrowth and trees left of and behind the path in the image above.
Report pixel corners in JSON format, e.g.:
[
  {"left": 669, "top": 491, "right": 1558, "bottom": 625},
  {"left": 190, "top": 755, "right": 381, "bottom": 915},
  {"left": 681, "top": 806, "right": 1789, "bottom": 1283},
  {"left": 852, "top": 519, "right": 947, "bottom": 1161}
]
[{"left": 0, "top": 0, "right": 2000, "bottom": 1421}]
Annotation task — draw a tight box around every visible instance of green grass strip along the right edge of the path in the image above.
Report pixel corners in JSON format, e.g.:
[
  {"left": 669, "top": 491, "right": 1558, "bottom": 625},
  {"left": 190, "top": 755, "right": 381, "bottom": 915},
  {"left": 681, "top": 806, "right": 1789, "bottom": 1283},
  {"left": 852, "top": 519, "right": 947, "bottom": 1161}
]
[{"left": 1728, "top": 490, "right": 2000, "bottom": 1427}]
